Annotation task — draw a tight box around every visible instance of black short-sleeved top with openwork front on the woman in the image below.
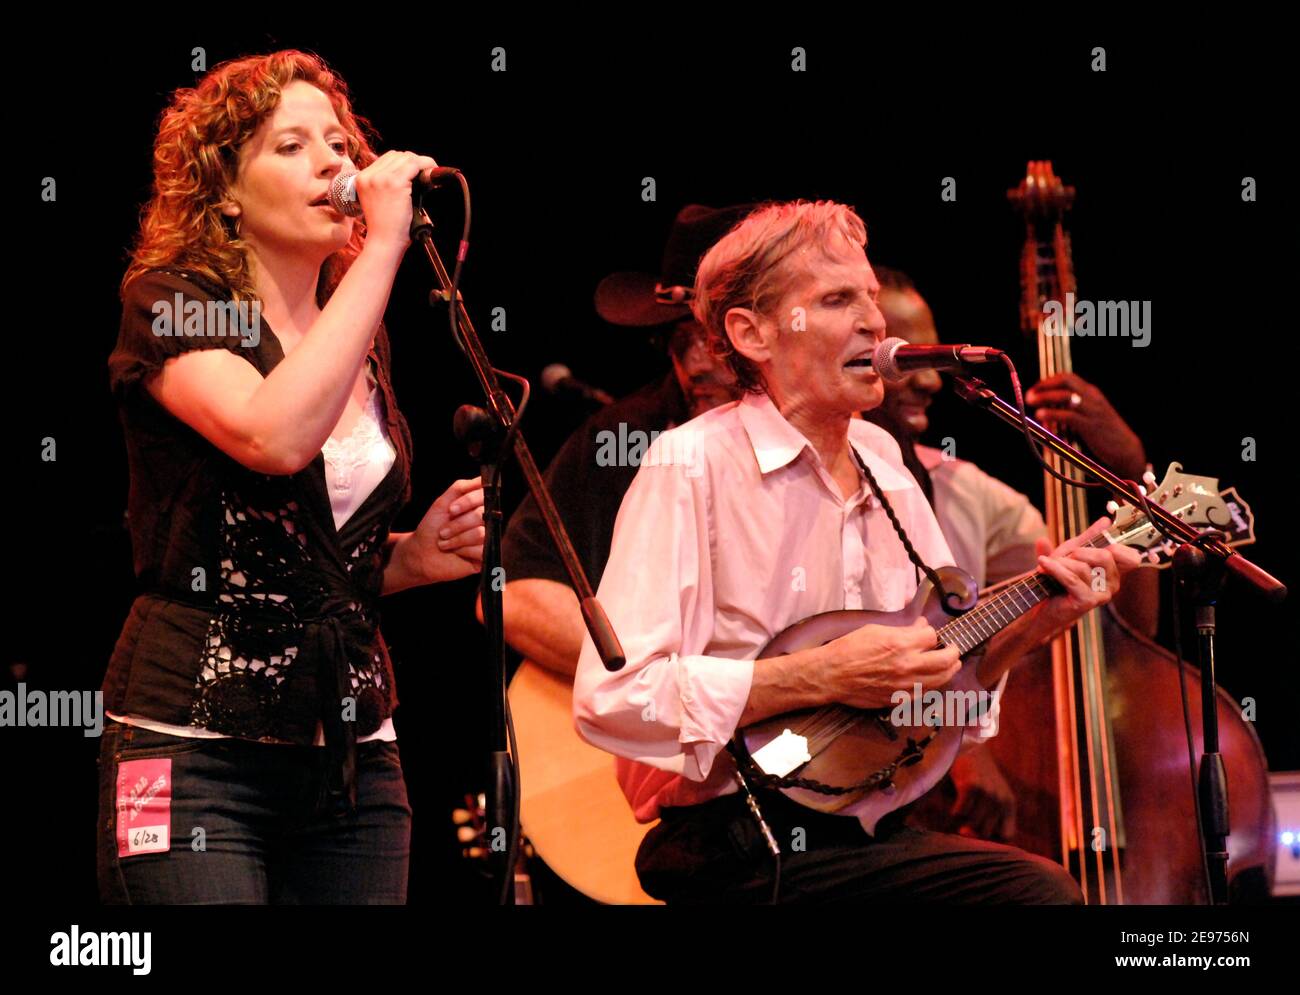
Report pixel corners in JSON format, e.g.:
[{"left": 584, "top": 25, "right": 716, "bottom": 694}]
[{"left": 103, "top": 269, "right": 411, "bottom": 785}]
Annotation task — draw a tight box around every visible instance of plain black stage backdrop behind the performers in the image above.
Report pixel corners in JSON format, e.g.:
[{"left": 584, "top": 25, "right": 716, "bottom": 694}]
[{"left": 10, "top": 17, "right": 1300, "bottom": 903}]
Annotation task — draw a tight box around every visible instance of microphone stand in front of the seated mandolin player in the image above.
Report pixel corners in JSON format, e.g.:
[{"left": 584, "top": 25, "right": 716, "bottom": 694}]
[{"left": 953, "top": 376, "right": 1287, "bottom": 905}]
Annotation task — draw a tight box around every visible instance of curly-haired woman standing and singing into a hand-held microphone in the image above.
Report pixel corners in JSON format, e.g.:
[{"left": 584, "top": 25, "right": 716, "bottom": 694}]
[{"left": 98, "top": 51, "right": 484, "bottom": 904}]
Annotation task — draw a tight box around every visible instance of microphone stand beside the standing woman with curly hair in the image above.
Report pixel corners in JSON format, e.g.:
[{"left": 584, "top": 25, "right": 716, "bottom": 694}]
[{"left": 411, "top": 185, "right": 627, "bottom": 905}]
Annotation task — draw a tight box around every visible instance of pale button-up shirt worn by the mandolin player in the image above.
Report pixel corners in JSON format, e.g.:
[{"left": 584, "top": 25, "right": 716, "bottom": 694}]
[{"left": 573, "top": 394, "right": 988, "bottom": 822}]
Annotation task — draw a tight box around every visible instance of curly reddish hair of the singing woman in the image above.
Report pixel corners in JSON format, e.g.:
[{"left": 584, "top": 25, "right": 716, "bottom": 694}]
[{"left": 121, "top": 49, "right": 374, "bottom": 307}]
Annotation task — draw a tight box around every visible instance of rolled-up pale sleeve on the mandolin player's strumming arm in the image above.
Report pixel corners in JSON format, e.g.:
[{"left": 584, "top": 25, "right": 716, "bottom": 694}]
[{"left": 573, "top": 436, "right": 754, "bottom": 780}]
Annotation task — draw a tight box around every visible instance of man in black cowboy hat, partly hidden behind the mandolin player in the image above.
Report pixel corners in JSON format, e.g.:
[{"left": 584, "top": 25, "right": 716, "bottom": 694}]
[{"left": 478, "top": 204, "right": 753, "bottom": 675}]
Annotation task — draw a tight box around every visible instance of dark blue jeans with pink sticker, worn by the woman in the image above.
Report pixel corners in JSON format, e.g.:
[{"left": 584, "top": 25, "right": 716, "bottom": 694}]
[{"left": 96, "top": 721, "right": 411, "bottom": 905}]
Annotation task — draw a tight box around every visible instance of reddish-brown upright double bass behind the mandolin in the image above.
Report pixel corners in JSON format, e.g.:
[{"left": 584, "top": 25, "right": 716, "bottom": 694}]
[{"left": 991, "top": 161, "right": 1273, "bottom": 904}]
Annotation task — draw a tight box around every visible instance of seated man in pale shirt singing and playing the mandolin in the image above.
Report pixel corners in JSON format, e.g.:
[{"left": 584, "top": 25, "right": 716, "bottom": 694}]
[{"left": 573, "top": 202, "right": 1139, "bottom": 904}]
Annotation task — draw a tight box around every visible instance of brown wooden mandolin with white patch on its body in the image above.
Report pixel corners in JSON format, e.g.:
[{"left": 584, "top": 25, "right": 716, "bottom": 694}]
[{"left": 731, "top": 463, "right": 1251, "bottom": 832}]
